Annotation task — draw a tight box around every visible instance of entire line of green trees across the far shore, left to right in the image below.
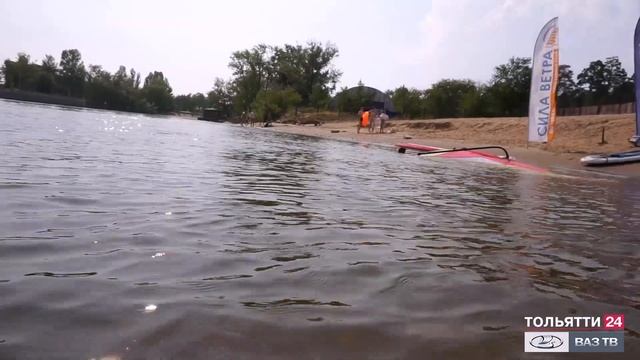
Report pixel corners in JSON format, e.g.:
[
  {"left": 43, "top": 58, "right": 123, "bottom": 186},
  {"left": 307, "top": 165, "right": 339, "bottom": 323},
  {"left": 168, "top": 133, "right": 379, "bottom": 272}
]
[{"left": 0, "top": 42, "right": 634, "bottom": 120}]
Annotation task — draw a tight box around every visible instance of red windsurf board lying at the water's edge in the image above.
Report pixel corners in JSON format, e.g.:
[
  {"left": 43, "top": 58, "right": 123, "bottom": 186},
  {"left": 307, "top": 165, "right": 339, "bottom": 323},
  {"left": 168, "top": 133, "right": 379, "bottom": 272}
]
[{"left": 396, "top": 143, "right": 549, "bottom": 174}]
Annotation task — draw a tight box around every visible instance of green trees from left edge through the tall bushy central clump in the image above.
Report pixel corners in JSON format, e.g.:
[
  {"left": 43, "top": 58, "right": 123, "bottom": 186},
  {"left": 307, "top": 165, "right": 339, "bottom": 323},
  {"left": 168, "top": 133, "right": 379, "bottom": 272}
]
[{"left": 0, "top": 42, "right": 341, "bottom": 119}]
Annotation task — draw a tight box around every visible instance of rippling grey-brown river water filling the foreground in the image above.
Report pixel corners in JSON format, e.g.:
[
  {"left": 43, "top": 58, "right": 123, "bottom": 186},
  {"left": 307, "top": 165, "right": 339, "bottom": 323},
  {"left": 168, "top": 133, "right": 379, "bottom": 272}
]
[{"left": 0, "top": 101, "right": 640, "bottom": 359}]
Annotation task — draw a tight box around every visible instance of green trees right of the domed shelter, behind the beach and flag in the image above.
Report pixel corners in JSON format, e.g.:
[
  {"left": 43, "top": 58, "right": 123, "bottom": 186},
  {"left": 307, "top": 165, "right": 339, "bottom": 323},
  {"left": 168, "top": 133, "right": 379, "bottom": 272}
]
[{"left": 364, "top": 57, "right": 635, "bottom": 119}]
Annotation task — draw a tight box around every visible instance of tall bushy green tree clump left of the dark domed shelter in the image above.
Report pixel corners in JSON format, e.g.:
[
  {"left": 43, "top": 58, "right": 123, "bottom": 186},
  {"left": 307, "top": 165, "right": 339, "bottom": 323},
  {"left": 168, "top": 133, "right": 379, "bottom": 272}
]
[{"left": 176, "top": 42, "right": 342, "bottom": 121}]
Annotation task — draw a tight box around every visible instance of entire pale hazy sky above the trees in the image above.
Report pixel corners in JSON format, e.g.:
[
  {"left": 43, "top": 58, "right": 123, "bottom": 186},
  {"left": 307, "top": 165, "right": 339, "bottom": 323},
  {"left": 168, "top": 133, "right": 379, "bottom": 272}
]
[{"left": 0, "top": 0, "right": 640, "bottom": 94}]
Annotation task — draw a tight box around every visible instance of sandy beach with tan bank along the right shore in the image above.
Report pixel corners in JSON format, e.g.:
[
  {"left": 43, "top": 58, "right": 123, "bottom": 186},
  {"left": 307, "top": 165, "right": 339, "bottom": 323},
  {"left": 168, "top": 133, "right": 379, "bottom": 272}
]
[{"left": 270, "top": 114, "right": 640, "bottom": 176}]
